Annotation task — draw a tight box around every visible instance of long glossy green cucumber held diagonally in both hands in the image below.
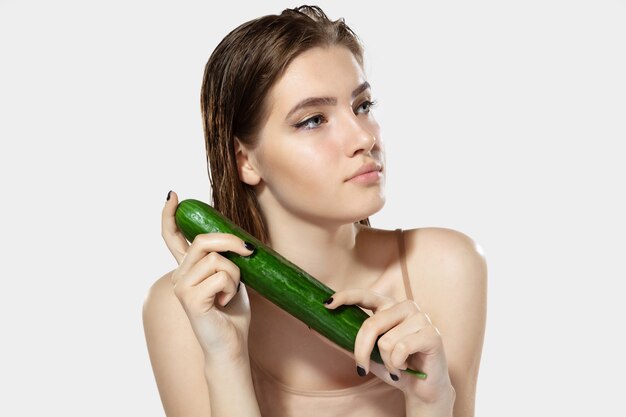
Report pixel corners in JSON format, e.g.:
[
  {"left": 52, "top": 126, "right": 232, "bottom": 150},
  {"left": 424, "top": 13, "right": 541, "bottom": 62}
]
[{"left": 175, "top": 199, "right": 426, "bottom": 379}]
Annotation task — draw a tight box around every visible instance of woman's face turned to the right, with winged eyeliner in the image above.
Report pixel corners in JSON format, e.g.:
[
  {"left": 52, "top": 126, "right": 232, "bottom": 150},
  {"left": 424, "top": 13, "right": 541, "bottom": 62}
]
[{"left": 241, "top": 47, "right": 385, "bottom": 223}]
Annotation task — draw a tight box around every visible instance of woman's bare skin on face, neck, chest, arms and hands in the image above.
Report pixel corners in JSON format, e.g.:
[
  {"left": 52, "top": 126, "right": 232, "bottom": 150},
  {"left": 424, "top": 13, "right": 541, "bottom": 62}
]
[{"left": 144, "top": 47, "right": 486, "bottom": 417}]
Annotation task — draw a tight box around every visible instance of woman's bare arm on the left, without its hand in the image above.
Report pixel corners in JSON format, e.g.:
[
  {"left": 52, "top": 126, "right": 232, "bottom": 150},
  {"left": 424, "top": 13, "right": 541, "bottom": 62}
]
[{"left": 143, "top": 274, "right": 261, "bottom": 417}]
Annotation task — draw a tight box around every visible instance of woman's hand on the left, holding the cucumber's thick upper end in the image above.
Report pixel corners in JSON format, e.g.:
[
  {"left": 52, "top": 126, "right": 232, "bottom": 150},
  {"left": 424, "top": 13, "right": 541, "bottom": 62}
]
[{"left": 161, "top": 191, "right": 254, "bottom": 363}]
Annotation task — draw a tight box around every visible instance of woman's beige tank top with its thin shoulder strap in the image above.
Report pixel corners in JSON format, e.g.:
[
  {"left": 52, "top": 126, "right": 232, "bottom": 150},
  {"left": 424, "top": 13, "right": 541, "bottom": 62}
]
[{"left": 250, "top": 229, "right": 413, "bottom": 417}]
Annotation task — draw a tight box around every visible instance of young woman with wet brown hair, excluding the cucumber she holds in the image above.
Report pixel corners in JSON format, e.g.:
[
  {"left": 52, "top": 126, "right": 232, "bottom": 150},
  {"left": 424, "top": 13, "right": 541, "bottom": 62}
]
[{"left": 144, "top": 6, "right": 486, "bottom": 417}]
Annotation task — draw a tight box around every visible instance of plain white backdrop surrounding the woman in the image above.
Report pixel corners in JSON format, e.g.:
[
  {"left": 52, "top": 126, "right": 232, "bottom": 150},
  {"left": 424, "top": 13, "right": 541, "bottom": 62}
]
[{"left": 0, "top": 0, "right": 626, "bottom": 416}]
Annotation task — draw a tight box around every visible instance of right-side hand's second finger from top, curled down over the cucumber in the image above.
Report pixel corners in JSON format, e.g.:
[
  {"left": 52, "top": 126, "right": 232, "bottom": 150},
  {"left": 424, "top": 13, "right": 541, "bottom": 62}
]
[{"left": 354, "top": 302, "right": 417, "bottom": 372}]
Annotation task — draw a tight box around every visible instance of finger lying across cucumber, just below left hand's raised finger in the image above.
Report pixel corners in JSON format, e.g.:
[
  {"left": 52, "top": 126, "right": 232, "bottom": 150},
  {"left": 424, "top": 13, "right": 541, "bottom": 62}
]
[{"left": 179, "top": 233, "right": 254, "bottom": 276}]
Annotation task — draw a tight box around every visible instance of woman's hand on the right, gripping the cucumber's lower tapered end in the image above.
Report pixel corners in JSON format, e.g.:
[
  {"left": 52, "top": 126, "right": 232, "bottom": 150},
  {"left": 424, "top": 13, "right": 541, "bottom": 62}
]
[{"left": 326, "top": 289, "right": 454, "bottom": 405}]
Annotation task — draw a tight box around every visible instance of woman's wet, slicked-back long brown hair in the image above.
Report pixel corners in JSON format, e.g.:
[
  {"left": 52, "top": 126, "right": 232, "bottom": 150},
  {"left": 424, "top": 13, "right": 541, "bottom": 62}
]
[{"left": 201, "top": 6, "right": 369, "bottom": 243}]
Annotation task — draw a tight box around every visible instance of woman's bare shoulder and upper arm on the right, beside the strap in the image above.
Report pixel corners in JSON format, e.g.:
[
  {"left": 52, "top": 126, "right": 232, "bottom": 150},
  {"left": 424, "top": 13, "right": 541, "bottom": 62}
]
[{"left": 404, "top": 228, "right": 487, "bottom": 417}]
